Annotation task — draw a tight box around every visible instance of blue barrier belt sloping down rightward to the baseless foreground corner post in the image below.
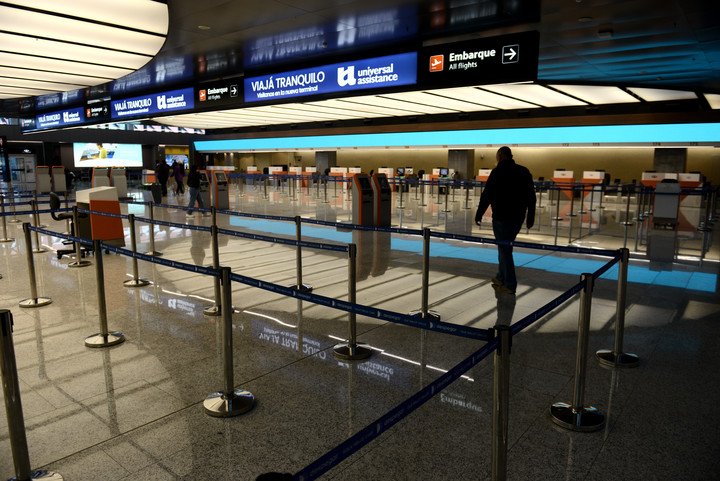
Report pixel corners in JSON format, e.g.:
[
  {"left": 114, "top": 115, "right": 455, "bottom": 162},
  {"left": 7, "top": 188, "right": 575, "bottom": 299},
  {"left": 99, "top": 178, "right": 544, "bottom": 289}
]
[{"left": 230, "top": 273, "right": 492, "bottom": 341}]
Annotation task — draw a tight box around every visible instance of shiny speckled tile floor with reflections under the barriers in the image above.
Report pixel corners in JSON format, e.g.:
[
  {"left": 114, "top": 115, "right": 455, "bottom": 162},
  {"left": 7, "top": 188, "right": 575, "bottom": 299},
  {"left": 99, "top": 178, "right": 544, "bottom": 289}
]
[{"left": 0, "top": 183, "right": 720, "bottom": 480}]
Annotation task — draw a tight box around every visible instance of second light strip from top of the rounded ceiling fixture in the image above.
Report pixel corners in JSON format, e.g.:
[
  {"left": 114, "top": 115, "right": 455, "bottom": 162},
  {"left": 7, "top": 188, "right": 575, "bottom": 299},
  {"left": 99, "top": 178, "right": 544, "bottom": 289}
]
[{"left": 0, "top": 2, "right": 165, "bottom": 56}]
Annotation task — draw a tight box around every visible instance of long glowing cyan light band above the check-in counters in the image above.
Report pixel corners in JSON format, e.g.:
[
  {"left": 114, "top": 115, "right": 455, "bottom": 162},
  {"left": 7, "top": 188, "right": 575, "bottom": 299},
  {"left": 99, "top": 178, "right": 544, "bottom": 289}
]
[{"left": 195, "top": 123, "right": 720, "bottom": 152}]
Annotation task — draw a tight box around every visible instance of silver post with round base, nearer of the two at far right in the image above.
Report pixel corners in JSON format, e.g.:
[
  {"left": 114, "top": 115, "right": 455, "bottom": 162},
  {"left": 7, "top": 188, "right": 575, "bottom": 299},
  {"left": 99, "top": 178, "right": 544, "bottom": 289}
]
[{"left": 550, "top": 273, "right": 605, "bottom": 432}]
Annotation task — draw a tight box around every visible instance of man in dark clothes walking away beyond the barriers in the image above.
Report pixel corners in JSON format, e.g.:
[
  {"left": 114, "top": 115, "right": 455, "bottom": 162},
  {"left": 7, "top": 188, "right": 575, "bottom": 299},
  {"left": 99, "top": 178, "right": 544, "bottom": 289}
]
[{"left": 475, "top": 146, "right": 535, "bottom": 295}]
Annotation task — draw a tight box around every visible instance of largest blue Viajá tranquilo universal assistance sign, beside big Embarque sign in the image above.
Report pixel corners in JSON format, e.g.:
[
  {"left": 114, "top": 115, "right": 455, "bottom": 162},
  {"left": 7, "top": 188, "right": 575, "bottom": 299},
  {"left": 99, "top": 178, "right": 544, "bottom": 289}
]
[{"left": 245, "top": 52, "right": 417, "bottom": 102}]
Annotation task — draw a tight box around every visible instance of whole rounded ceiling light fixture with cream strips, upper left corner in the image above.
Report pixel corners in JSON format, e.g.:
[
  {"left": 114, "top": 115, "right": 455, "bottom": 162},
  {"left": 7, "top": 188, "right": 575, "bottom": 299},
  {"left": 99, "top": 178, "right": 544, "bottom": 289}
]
[{"left": 0, "top": 0, "right": 169, "bottom": 99}]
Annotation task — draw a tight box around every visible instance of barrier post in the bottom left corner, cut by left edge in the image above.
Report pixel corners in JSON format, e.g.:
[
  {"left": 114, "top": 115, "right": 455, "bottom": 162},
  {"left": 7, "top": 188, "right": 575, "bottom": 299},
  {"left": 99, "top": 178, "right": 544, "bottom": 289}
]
[{"left": 0, "top": 309, "right": 63, "bottom": 481}]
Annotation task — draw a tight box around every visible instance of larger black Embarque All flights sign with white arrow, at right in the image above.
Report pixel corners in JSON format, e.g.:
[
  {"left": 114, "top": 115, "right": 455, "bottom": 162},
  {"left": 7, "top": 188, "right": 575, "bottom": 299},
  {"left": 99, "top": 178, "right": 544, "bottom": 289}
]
[{"left": 419, "top": 32, "right": 539, "bottom": 88}]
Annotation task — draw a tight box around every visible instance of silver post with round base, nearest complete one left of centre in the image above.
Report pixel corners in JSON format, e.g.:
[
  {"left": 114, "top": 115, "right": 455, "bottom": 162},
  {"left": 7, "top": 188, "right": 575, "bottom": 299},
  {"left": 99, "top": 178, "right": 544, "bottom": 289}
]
[{"left": 203, "top": 267, "right": 255, "bottom": 418}]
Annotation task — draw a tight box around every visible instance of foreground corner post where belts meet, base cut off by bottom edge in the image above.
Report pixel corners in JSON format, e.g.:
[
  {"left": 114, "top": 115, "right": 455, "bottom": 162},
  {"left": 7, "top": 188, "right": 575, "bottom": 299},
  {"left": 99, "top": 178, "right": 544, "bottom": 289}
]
[{"left": 492, "top": 325, "right": 512, "bottom": 481}]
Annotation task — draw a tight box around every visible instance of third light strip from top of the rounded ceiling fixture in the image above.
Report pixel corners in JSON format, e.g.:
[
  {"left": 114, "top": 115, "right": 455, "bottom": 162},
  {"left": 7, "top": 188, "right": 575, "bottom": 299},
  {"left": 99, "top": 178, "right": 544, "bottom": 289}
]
[{"left": 0, "top": 33, "right": 152, "bottom": 70}]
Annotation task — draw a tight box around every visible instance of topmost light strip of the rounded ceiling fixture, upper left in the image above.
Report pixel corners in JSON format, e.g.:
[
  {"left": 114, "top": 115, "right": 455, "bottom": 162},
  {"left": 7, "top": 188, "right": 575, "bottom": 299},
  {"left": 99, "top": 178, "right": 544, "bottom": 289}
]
[{"left": 3, "top": 0, "right": 169, "bottom": 35}]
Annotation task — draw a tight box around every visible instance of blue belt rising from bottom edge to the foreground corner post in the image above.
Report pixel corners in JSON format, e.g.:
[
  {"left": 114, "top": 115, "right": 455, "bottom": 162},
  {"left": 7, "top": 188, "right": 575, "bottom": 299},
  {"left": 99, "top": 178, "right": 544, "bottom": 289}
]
[{"left": 292, "top": 338, "right": 499, "bottom": 481}]
